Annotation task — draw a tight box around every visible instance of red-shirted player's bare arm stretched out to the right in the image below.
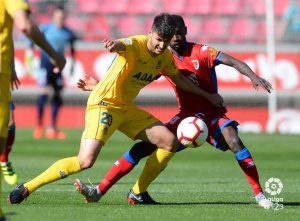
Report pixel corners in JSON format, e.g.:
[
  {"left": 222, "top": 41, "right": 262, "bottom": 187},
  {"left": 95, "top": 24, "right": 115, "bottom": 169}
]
[{"left": 220, "top": 53, "right": 273, "bottom": 93}]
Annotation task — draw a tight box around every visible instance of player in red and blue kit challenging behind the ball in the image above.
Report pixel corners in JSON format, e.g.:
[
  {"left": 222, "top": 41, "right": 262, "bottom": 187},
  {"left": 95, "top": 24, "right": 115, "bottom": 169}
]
[{"left": 76, "top": 15, "right": 272, "bottom": 207}]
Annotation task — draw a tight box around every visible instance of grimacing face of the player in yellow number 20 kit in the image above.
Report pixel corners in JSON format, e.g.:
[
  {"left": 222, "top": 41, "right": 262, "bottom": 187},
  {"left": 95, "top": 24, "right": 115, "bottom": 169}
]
[{"left": 147, "top": 31, "right": 171, "bottom": 55}]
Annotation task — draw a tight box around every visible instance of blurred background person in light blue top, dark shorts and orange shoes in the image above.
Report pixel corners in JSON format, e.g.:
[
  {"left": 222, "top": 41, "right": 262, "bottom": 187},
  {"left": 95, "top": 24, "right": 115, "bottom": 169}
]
[{"left": 27, "top": 7, "right": 76, "bottom": 139}]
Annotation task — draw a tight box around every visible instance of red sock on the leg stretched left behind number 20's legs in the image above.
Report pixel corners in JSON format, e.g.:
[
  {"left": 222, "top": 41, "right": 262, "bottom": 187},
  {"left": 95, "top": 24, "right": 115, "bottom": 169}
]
[{"left": 98, "top": 156, "right": 135, "bottom": 195}]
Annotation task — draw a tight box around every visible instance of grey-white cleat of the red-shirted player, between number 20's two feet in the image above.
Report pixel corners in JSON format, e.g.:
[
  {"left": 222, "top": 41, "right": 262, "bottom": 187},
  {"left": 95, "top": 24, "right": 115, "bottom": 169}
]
[{"left": 74, "top": 179, "right": 102, "bottom": 203}]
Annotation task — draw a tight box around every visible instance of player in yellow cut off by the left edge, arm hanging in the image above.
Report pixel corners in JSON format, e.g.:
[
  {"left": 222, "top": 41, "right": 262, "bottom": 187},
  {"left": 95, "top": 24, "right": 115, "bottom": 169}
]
[{"left": 0, "top": 0, "right": 66, "bottom": 217}]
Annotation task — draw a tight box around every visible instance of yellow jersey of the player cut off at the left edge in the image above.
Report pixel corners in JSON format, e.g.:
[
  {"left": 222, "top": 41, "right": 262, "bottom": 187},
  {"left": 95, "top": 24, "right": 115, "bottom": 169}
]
[{"left": 0, "top": 0, "right": 30, "bottom": 79}]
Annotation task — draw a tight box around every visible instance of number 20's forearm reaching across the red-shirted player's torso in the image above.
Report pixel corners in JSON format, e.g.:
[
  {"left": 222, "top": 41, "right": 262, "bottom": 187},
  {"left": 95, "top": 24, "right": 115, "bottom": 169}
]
[{"left": 169, "top": 72, "right": 224, "bottom": 107}]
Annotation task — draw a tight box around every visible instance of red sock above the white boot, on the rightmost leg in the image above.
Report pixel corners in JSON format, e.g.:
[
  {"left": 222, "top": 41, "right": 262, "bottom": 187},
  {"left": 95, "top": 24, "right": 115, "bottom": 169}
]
[{"left": 238, "top": 156, "right": 263, "bottom": 195}]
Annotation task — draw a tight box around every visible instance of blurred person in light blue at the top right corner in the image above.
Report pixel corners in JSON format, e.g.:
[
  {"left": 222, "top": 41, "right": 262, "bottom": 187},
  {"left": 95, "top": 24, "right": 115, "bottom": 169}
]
[{"left": 280, "top": 0, "right": 300, "bottom": 42}]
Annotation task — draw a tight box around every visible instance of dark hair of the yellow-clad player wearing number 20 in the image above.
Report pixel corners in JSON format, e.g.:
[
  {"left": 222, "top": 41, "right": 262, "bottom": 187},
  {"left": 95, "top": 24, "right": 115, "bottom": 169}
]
[{"left": 152, "top": 13, "right": 176, "bottom": 39}]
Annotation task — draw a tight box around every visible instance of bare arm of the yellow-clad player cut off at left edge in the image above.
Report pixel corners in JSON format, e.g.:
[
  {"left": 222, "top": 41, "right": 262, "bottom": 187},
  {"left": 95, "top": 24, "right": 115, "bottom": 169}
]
[{"left": 14, "top": 9, "right": 66, "bottom": 71}]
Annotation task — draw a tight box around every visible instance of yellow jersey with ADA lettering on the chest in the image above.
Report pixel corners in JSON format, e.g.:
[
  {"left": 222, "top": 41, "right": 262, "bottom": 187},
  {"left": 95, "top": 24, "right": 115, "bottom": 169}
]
[{"left": 88, "top": 35, "right": 178, "bottom": 108}]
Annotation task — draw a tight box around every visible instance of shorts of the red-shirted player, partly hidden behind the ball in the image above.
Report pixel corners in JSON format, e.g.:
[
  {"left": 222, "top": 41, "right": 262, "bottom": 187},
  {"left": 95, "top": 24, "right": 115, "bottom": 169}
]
[{"left": 166, "top": 113, "right": 239, "bottom": 151}]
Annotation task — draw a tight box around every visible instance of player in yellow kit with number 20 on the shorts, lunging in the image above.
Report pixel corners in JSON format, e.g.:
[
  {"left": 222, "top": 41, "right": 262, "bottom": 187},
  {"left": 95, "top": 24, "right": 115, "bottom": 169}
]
[{"left": 9, "top": 13, "right": 223, "bottom": 203}]
